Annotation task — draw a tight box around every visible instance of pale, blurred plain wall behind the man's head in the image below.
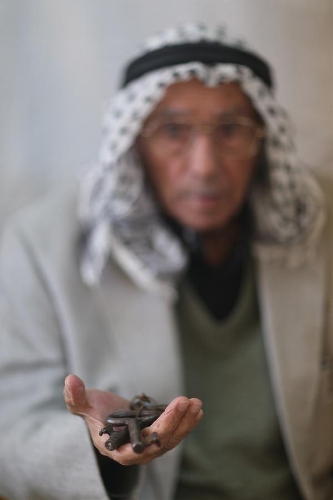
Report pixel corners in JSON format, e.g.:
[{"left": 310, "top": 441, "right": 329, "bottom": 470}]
[{"left": 0, "top": 0, "right": 333, "bottom": 227}]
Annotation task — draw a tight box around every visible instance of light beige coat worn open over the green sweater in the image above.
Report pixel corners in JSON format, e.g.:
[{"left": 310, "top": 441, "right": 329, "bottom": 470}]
[{"left": 0, "top": 185, "right": 333, "bottom": 500}]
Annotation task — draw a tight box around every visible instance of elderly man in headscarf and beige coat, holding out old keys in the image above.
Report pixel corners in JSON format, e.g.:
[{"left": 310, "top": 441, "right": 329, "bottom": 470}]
[{"left": 0, "top": 25, "right": 333, "bottom": 500}]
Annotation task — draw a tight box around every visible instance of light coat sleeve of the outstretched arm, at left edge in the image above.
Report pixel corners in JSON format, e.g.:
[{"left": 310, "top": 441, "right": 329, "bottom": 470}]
[{"left": 0, "top": 227, "right": 116, "bottom": 500}]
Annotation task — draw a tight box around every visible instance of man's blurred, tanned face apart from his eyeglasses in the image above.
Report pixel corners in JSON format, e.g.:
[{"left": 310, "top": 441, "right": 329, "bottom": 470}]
[{"left": 137, "top": 79, "right": 256, "bottom": 232}]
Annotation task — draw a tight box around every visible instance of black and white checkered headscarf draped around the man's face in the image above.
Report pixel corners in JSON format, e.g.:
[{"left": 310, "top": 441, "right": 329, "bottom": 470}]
[{"left": 79, "top": 24, "right": 325, "bottom": 290}]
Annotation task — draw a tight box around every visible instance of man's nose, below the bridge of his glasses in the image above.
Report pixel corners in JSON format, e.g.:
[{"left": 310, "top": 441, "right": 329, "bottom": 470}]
[{"left": 188, "top": 133, "right": 218, "bottom": 177}]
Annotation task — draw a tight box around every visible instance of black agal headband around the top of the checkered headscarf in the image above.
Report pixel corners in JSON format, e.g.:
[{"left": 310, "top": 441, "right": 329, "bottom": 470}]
[{"left": 122, "top": 41, "right": 273, "bottom": 88}]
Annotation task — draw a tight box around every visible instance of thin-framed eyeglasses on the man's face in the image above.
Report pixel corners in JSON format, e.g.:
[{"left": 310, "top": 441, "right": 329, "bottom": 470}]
[{"left": 141, "top": 116, "right": 264, "bottom": 159}]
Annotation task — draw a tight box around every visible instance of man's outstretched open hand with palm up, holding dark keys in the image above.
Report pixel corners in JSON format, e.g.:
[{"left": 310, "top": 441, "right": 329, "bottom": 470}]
[{"left": 64, "top": 375, "right": 203, "bottom": 465}]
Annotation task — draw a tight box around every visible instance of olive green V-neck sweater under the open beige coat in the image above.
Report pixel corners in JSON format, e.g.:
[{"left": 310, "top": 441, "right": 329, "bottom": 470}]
[{"left": 175, "top": 262, "right": 301, "bottom": 500}]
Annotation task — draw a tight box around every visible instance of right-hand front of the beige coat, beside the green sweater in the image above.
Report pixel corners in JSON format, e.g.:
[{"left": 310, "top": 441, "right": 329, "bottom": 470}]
[{"left": 258, "top": 250, "right": 325, "bottom": 499}]
